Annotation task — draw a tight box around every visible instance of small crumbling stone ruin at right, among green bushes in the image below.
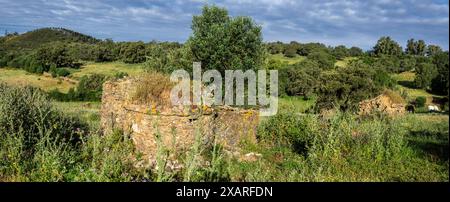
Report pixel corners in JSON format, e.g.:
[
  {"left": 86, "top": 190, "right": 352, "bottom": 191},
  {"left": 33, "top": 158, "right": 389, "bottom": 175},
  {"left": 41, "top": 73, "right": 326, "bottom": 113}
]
[{"left": 359, "top": 94, "right": 406, "bottom": 116}]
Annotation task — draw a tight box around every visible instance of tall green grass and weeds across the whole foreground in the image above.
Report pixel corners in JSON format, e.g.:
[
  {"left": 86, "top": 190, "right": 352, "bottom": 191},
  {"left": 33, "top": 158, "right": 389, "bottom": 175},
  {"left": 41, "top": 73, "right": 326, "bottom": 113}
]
[{"left": 0, "top": 85, "right": 449, "bottom": 182}]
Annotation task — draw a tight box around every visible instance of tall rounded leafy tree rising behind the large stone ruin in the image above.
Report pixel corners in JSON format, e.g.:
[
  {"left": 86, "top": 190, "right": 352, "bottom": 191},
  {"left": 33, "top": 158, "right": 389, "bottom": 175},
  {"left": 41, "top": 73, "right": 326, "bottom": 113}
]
[{"left": 187, "top": 6, "right": 265, "bottom": 73}]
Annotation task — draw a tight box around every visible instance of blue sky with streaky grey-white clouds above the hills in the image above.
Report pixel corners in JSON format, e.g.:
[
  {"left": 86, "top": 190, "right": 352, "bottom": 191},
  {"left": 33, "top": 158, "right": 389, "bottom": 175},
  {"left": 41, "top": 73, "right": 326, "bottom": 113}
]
[{"left": 0, "top": 0, "right": 449, "bottom": 50}]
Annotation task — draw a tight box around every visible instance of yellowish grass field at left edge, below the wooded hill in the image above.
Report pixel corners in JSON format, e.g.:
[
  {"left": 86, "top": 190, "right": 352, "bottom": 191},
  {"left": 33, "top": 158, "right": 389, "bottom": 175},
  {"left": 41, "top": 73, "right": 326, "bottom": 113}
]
[{"left": 0, "top": 68, "right": 76, "bottom": 92}]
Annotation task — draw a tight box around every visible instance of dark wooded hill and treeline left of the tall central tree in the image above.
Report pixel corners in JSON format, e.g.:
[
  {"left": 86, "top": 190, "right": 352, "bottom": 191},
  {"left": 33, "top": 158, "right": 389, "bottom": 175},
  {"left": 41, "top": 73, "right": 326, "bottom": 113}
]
[{"left": 0, "top": 28, "right": 181, "bottom": 73}]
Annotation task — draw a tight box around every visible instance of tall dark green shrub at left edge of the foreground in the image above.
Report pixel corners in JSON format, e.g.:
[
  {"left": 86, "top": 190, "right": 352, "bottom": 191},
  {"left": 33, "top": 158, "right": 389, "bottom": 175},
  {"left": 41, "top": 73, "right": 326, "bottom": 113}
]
[{"left": 0, "top": 84, "right": 86, "bottom": 150}]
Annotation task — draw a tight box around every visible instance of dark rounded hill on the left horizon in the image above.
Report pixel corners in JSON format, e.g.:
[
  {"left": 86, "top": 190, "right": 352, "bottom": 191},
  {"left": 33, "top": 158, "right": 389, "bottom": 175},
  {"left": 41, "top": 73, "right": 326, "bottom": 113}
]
[{"left": 0, "top": 28, "right": 100, "bottom": 50}]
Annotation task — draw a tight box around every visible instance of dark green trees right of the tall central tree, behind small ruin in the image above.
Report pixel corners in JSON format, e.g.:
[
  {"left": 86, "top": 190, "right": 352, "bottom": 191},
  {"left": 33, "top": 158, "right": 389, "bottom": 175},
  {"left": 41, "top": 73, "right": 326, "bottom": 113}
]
[{"left": 266, "top": 37, "right": 449, "bottom": 103}]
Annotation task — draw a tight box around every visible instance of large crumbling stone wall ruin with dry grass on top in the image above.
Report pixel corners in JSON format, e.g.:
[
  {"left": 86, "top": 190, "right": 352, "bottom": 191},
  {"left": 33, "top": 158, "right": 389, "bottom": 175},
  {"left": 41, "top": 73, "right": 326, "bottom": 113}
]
[{"left": 101, "top": 77, "right": 259, "bottom": 166}]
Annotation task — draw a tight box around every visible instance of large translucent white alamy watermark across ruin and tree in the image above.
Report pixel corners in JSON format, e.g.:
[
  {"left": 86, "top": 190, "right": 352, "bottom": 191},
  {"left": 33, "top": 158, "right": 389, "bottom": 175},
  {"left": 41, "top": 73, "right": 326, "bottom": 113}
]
[{"left": 170, "top": 63, "right": 278, "bottom": 116}]
